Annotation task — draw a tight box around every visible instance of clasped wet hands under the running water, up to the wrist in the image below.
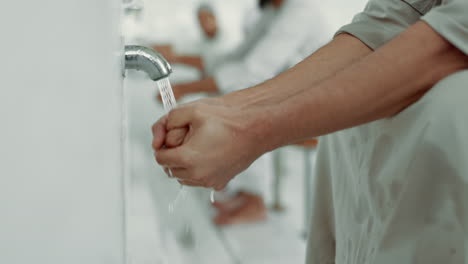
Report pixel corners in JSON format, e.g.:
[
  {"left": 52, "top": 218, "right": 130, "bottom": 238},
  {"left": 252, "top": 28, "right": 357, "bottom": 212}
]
[{"left": 153, "top": 98, "right": 268, "bottom": 190}]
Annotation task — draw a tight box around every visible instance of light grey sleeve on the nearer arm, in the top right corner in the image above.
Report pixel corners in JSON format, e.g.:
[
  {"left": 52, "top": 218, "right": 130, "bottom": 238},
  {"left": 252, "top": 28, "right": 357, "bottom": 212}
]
[{"left": 421, "top": 0, "right": 468, "bottom": 55}]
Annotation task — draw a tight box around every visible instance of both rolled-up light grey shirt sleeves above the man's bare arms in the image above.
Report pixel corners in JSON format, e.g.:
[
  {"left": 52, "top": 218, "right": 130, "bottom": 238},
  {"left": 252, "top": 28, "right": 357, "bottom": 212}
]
[{"left": 337, "top": 0, "right": 468, "bottom": 54}]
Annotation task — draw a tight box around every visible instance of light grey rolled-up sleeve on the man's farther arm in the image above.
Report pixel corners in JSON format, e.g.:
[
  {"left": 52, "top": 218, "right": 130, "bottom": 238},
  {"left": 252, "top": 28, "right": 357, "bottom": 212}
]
[{"left": 335, "top": 0, "right": 422, "bottom": 50}]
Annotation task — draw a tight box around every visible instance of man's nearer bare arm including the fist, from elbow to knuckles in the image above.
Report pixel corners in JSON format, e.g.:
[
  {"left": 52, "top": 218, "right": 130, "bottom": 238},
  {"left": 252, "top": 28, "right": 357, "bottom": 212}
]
[{"left": 153, "top": 22, "right": 468, "bottom": 189}]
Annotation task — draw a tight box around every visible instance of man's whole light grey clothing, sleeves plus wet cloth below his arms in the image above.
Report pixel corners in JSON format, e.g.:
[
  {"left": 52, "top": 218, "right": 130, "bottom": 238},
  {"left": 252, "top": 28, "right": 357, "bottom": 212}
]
[{"left": 307, "top": 0, "right": 468, "bottom": 264}]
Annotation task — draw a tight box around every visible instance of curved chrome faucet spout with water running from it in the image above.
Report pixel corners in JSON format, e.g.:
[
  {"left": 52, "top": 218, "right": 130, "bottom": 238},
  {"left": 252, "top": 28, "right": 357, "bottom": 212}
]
[{"left": 125, "top": 45, "right": 172, "bottom": 81}]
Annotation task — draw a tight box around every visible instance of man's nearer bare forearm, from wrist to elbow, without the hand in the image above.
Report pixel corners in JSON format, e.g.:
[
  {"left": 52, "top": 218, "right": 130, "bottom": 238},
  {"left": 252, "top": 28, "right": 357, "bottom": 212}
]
[{"left": 270, "top": 22, "right": 468, "bottom": 147}]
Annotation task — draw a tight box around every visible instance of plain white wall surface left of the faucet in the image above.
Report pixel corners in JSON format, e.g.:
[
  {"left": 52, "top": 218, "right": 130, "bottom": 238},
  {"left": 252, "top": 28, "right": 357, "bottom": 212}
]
[{"left": 0, "top": 0, "right": 124, "bottom": 264}]
